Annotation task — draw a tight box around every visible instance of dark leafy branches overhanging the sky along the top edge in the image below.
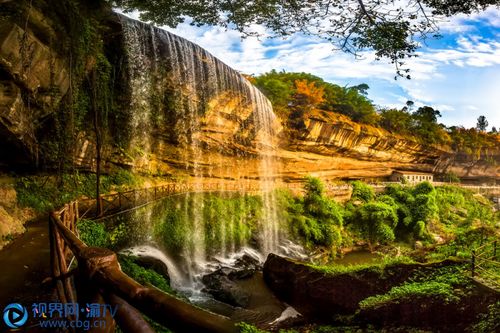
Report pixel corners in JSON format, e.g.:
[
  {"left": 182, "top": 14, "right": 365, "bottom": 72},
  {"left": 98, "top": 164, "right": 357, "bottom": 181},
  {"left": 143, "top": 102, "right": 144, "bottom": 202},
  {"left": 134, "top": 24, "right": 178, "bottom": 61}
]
[{"left": 112, "top": 0, "right": 499, "bottom": 78}]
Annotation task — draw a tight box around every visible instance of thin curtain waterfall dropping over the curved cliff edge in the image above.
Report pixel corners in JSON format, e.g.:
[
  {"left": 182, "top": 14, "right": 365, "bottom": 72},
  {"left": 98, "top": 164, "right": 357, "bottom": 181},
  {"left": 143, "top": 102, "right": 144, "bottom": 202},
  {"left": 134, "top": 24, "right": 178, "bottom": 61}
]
[{"left": 120, "top": 16, "right": 280, "bottom": 283}]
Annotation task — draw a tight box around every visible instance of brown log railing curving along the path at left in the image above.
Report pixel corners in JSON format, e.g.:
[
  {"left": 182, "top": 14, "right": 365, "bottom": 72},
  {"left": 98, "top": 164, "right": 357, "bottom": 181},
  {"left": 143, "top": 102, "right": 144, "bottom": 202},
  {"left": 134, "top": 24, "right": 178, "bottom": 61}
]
[{"left": 49, "top": 184, "right": 250, "bottom": 333}]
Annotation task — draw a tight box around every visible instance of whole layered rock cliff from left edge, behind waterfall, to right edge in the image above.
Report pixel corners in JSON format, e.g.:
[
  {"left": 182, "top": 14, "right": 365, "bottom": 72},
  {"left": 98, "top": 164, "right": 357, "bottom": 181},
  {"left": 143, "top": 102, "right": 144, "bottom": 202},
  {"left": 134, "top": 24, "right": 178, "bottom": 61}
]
[{"left": 0, "top": 0, "right": 500, "bottom": 183}]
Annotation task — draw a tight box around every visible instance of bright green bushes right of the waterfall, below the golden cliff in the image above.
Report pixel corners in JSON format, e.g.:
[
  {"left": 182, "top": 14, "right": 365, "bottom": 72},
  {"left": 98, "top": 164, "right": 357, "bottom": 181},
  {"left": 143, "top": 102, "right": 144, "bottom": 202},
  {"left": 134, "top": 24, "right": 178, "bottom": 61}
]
[{"left": 280, "top": 178, "right": 500, "bottom": 258}]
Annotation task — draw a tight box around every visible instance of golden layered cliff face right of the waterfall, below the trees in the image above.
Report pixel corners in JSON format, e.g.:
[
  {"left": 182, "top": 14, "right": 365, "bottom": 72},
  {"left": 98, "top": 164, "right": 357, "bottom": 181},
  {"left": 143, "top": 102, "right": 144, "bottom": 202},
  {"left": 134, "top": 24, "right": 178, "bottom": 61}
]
[{"left": 280, "top": 110, "right": 500, "bottom": 179}]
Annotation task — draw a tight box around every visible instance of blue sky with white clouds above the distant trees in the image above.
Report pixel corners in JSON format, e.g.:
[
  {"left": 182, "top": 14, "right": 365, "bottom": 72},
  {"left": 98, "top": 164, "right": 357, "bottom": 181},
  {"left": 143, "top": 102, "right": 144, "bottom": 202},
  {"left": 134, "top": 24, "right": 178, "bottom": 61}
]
[{"left": 118, "top": 8, "right": 500, "bottom": 129}]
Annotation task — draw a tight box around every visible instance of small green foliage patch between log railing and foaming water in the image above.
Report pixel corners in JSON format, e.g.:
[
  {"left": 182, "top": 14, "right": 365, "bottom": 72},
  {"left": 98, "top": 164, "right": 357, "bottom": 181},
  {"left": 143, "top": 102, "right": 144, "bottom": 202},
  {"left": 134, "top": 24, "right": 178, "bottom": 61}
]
[{"left": 119, "top": 255, "right": 175, "bottom": 294}]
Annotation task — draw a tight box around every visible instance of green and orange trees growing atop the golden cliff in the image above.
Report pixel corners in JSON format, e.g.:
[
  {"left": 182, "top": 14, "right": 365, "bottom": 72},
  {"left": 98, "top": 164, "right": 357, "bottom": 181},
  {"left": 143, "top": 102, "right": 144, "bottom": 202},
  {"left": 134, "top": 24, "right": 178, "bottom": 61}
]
[{"left": 252, "top": 70, "right": 498, "bottom": 152}]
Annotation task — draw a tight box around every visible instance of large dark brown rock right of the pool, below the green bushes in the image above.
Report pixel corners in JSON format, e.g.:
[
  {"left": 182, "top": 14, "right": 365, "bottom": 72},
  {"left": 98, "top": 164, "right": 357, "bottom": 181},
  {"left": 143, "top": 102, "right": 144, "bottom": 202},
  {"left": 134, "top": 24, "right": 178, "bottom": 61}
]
[{"left": 263, "top": 254, "right": 462, "bottom": 320}]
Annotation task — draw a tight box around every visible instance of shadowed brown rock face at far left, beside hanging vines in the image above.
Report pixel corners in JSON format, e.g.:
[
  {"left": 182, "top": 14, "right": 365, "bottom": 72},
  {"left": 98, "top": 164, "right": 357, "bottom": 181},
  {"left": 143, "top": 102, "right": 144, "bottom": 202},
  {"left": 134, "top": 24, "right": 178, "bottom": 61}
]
[{"left": 0, "top": 4, "right": 70, "bottom": 165}]
